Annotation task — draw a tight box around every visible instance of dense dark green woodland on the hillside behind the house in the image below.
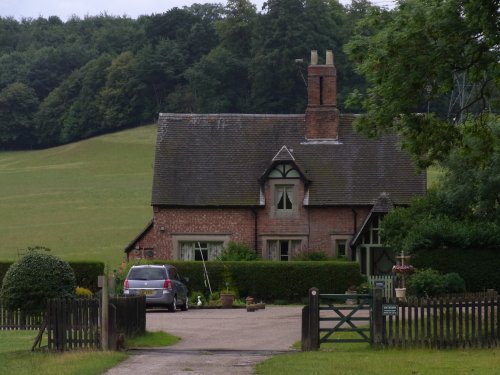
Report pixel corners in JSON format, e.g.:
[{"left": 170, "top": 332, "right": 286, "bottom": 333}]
[{"left": 0, "top": 0, "right": 374, "bottom": 149}]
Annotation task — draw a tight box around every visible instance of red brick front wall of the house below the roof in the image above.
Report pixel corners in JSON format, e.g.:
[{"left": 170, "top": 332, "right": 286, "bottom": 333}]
[{"left": 129, "top": 188, "right": 370, "bottom": 259}]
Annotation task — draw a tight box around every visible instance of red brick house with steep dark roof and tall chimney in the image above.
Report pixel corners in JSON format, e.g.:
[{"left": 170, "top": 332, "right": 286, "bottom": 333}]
[{"left": 125, "top": 51, "right": 426, "bottom": 274}]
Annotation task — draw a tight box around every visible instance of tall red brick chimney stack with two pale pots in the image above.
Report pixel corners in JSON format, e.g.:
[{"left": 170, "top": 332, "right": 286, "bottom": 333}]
[{"left": 306, "top": 50, "right": 339, "bottom": 140}]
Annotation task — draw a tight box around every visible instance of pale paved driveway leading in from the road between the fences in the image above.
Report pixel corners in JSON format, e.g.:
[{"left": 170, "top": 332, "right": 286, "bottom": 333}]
[{"left": 106, "top": 306, "right": 301, "bottom": 375}]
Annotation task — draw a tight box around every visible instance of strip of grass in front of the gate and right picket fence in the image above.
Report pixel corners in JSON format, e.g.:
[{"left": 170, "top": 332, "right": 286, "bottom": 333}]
[{"left": 257, "top": 344, "right": 500, "bottom": 375}]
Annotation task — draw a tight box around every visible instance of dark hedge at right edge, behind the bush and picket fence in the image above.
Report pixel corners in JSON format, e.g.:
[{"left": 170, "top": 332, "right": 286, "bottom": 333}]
[{"left": 411, "top": 248, "right": 500, "bottom": 292}]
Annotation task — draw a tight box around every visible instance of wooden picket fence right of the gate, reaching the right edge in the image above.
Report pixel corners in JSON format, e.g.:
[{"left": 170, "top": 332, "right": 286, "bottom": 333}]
[{"left": 380, "top": 296, "right": 500, "bottom": 349}]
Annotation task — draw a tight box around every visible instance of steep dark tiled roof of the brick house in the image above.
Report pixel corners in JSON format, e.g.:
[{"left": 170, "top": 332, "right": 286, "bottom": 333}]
[{"left": 152, "top": 113, "right": 426, "bottom": 206}]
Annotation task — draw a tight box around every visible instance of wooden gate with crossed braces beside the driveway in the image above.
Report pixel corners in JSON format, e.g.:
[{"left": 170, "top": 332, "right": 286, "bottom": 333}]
[{"left": 302, "top": 288, "right": 373, "bottom": 351}]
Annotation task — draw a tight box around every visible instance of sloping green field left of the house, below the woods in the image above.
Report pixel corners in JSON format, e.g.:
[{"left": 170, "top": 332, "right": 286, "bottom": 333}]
[{"left": 0, "top": 125, "right": 156, "bottom": 269}]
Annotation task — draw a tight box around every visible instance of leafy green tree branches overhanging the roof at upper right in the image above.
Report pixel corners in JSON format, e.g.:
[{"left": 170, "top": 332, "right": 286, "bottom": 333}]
[{"left": 346, "top": 0, "right": 500, "bottom": 168}]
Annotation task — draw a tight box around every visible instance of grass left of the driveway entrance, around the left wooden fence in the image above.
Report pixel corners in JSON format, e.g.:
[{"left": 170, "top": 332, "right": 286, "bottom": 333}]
[{"left": 0, "top": 331, "right": 179, "bottom": 375}]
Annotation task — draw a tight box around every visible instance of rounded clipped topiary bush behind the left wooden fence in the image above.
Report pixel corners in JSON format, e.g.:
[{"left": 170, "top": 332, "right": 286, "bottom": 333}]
[{"left": 1, "top": 249, "right": 75, "bottom": 312}]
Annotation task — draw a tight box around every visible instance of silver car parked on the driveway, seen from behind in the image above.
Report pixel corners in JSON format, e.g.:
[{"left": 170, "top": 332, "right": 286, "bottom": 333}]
[{"left": 123, "top": 264, "right": 188, "bottom": 312}]
